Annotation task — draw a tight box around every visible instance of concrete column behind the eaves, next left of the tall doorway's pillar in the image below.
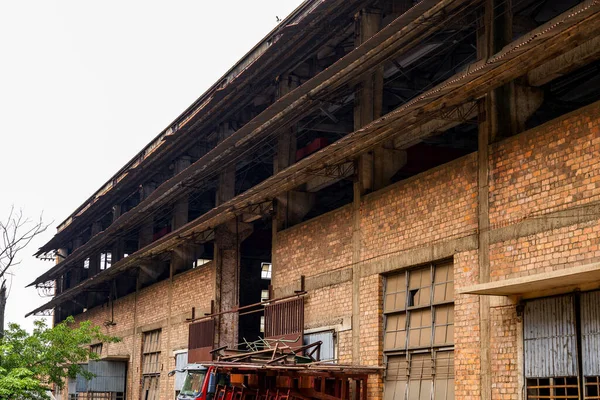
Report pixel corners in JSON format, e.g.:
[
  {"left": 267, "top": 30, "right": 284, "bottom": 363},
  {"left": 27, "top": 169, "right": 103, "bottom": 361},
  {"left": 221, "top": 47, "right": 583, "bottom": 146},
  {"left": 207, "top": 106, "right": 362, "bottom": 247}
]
[{"left": 170, "top": 156, "right": 194, "bottom": 277}]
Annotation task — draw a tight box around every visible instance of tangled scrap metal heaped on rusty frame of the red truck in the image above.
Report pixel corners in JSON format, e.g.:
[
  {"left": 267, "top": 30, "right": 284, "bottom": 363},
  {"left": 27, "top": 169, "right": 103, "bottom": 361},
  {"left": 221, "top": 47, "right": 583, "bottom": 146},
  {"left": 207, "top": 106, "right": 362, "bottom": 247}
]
[{"left": 203, "top": 338, "right": 381, "bottom": 400}]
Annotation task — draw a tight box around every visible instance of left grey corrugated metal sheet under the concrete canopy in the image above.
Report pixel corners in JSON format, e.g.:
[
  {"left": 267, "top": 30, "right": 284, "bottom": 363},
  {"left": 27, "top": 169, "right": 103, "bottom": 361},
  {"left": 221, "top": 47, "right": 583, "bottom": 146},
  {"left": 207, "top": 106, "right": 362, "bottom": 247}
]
[{"left": 523, "top": 296, "right": 577, "bottom": 378}]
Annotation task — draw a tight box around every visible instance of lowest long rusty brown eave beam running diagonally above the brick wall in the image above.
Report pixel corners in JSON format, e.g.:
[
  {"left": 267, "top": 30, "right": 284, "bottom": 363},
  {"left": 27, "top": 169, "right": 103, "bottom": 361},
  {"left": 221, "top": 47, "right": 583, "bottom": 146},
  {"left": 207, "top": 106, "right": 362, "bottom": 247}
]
[{"left": 27, "top": 0, "right": 600, "bottom": 315}]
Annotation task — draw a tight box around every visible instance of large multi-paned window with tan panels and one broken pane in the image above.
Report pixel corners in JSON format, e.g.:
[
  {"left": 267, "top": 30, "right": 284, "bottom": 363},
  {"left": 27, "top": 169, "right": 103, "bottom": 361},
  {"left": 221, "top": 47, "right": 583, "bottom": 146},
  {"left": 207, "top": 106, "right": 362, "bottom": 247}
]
[{"left": 383, "top": 262, "right": 454, "bottom": 400}]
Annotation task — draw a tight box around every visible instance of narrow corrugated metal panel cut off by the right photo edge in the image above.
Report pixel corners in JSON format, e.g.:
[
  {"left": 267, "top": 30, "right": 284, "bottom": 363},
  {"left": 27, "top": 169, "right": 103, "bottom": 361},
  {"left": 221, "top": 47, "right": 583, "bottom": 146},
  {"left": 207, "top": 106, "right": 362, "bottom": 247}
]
[{"left": 581, "top": 291, "right": 600, "bottom": 376}]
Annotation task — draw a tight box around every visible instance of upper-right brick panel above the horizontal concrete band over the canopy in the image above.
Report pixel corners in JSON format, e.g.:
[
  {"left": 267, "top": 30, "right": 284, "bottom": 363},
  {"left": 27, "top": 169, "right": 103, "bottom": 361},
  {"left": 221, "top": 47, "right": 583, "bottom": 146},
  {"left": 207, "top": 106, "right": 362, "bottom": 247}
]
[{"left": 490, "top": 102, "right": 600, "bottom": 226}]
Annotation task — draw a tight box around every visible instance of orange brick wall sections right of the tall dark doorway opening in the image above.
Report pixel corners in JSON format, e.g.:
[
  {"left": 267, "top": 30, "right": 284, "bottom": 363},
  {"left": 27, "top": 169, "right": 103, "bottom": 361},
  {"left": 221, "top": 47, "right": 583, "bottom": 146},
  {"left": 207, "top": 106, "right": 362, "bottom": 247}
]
[{"left": 273, "top": 103, "right": 600, "bottom": 399}]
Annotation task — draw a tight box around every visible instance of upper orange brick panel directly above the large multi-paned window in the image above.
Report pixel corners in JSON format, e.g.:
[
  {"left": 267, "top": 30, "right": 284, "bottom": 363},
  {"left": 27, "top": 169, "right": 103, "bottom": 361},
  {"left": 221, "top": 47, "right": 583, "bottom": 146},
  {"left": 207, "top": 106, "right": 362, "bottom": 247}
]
[{"left": 360, "top": 154, "right": 477, "bottom": 261}]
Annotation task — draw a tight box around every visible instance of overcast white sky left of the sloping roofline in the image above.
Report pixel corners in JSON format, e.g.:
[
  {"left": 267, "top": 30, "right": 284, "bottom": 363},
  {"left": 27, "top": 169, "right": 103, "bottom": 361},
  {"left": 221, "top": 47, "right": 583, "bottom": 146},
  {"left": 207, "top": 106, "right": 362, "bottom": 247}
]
[{"left": 0, "top": 0, "right": 302, "bottom": 329}]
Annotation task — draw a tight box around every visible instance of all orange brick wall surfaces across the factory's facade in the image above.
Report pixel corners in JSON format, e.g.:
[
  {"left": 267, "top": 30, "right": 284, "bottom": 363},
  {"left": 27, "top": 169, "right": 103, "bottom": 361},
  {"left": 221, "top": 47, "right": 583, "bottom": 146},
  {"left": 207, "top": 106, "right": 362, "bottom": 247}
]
[{"left": 63, "top": 103, "right": 600, "bottom": 400}]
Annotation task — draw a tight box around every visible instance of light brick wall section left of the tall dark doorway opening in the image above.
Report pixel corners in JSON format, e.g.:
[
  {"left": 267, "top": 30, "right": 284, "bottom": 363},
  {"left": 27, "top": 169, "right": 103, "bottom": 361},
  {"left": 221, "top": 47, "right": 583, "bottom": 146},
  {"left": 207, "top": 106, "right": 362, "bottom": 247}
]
[{"left": 76, "top": 263, "right": 214, "bottom": 399}]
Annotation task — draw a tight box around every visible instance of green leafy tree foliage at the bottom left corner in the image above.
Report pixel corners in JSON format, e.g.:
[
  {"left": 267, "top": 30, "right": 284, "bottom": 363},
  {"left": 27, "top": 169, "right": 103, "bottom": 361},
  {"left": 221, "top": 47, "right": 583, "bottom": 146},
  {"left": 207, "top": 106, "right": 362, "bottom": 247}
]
[{"left": 0, "top": 317, "right": 119, "bottom": 400}]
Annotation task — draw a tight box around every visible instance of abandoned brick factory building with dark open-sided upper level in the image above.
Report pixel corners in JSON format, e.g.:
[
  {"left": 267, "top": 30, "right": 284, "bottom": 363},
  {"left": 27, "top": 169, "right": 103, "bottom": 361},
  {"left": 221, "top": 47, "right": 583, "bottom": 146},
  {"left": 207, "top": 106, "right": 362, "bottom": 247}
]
[{"left": 29, "top": 0, "right": 600, "bottom": 400}]
